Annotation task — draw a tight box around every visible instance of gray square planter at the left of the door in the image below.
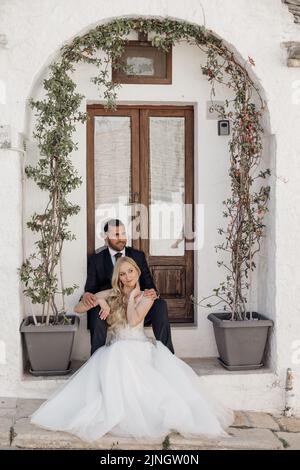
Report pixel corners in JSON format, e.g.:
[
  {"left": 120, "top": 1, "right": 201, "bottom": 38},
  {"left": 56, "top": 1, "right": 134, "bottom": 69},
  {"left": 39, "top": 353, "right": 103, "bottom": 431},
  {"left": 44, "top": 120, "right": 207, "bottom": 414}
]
[{"left": 20, "top": 315, "right": 79, "bottom": 375}]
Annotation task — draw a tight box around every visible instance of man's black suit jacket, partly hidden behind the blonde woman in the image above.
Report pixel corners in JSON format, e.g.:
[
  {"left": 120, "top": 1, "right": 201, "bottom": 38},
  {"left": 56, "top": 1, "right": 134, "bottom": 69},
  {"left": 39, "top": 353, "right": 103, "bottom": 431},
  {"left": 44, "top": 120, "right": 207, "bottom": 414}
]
[{"left": 84, "top": 247, "right": 156, "bottom": 328}]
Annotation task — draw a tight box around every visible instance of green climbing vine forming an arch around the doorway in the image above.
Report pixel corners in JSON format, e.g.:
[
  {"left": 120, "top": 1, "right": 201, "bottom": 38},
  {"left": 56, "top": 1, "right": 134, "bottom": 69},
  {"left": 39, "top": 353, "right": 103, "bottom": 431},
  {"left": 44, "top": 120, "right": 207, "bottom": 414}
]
[{"left": 20, "top": 18, "right": 270, "bottom": 323}]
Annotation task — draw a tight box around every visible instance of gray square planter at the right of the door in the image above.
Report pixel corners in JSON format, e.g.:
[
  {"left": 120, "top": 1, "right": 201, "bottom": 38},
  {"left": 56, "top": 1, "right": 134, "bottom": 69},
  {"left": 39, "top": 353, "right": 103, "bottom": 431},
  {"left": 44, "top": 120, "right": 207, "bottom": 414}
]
[{"left": 207, "top": 313, "right": 273, "bottom": 370}]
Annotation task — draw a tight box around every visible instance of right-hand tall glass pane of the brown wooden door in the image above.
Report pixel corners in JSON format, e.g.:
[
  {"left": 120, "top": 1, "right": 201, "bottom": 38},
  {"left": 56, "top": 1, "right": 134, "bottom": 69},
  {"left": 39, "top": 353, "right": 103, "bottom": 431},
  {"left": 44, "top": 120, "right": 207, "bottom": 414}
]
[{"left": 149, "top": 117, "right": 185, "bottom": 256}]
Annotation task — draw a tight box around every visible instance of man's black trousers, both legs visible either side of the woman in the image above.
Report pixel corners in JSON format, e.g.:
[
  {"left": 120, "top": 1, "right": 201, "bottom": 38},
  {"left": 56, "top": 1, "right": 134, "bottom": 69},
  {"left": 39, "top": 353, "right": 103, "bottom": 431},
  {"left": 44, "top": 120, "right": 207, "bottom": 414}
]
[{"left": 89, "top": 299, "right": 174, "bottom": 354}]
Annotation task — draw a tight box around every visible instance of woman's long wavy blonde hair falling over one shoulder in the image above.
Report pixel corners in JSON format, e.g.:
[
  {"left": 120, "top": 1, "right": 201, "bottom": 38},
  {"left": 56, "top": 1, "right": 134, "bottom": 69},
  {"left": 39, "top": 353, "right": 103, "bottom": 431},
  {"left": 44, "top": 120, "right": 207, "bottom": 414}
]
[{"left": 106, "top": 256, "right": 141, "bottom": 331}]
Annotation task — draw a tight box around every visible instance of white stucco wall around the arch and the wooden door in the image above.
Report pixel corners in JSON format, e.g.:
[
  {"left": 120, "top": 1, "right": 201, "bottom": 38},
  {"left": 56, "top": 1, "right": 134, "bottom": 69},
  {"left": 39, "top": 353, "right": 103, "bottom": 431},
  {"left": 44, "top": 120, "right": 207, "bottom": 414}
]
[{"left": 0, "top": 0, "right": 300, "bottom": 409}]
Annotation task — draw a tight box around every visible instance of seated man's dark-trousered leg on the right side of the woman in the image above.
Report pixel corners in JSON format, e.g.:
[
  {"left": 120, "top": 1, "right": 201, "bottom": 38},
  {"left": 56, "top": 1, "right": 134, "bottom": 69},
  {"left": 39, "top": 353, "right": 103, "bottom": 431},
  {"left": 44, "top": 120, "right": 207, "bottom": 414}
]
[{"left": 145, "top": 299, "right": 174, "bottom": 354}]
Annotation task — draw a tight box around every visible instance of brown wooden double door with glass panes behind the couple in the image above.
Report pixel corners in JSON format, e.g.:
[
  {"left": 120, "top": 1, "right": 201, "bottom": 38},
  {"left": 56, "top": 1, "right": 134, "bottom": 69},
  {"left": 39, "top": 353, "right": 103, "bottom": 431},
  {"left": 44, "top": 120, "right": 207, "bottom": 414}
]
[{"left": 87, "top": 105, "right": 194, "bottom": 323}]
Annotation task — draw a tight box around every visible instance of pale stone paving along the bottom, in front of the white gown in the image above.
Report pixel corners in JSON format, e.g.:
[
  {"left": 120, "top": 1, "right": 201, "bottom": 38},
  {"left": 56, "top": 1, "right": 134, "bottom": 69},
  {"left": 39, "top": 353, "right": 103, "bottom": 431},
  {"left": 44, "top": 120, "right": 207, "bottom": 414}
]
[{"left": 0, "top": 398, "right": 290, "bottom": 450}]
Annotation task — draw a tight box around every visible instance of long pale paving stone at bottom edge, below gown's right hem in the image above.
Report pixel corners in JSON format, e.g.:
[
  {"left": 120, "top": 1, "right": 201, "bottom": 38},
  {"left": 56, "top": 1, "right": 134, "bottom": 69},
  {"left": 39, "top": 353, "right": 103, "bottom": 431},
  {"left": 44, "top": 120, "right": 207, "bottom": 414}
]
[{"left": 170, "top": 428, "right": 283, "bottom": 450}]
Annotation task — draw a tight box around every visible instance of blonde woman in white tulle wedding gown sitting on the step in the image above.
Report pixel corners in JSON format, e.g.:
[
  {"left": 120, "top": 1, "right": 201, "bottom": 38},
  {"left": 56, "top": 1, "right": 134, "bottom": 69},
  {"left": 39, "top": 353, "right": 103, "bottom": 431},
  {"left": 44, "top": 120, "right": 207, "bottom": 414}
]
[{"left": 31, "top": 256, "right": 233, "bottom": 442}]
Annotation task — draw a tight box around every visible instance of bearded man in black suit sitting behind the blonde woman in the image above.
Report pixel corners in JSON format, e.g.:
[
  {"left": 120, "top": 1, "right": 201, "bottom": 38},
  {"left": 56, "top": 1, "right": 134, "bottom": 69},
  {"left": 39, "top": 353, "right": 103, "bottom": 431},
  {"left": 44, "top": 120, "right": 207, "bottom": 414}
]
[{"left": 82, "top": 219, "right": 174, "bottom": 354}]
